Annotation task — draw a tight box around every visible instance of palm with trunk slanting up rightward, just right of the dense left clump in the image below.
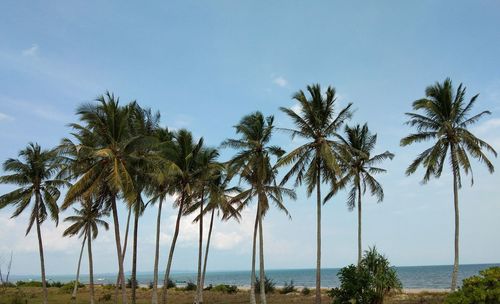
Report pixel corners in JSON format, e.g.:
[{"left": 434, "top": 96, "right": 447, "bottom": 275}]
[{"left": 162, "top": 129, "right": 203, "bottom": 304}]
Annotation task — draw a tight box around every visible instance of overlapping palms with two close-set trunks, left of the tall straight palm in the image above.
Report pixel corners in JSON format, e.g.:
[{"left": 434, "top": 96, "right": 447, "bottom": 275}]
[{"left": 222, "top": 112, "right": 295, "bottom": 304}]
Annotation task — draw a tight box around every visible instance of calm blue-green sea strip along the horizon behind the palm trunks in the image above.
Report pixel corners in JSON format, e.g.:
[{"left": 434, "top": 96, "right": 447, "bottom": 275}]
[{"left": 11, "top": 264, "right": 500, "bottom": 289}]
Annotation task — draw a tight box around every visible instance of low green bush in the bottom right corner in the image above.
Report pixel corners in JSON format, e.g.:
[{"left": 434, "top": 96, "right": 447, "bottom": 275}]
[{"left": 446, "top": 267, "right": 500, "bottom": 304}]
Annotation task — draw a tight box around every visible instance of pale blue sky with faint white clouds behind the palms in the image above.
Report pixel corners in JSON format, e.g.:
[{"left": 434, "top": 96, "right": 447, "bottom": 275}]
[{"left": 0, "top": 0, "right": 500, "bottom": 275}]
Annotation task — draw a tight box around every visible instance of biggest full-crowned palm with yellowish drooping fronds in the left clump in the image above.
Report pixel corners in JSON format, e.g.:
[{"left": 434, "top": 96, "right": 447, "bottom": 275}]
[{"left": 62, "top": 92, "right": 140, "bottom": 304}]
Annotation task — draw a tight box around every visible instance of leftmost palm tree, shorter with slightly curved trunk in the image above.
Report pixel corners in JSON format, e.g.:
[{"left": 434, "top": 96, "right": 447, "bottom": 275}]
[{"left": 0, "top": 143, "right": 68, "bottom": 304}]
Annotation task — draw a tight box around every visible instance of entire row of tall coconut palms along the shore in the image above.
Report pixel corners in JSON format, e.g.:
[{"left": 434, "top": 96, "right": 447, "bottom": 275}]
[{"left": 0, "top": 79, "right": 496, "bottom": 304}]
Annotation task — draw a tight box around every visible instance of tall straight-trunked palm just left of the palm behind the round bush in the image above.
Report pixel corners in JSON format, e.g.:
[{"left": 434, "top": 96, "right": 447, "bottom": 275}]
[{"left": 278, "top": 85, "right": 352, "bottom": 303}]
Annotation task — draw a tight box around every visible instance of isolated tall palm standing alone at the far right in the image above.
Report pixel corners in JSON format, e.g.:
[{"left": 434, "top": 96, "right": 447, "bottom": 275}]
[{"left": 401, "top": 78, "right": 497, "bottom": 290}]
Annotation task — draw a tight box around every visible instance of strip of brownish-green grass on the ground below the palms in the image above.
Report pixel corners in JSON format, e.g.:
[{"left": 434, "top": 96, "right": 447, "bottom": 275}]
[{"left": 0, "top": 286, "right": 446, "bottom": 304}]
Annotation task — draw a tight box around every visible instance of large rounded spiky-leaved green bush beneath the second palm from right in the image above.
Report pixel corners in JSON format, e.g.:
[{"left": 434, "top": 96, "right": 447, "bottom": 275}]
[{"left": 328, "top": 247, "right": 402, "bottom": 304}]
